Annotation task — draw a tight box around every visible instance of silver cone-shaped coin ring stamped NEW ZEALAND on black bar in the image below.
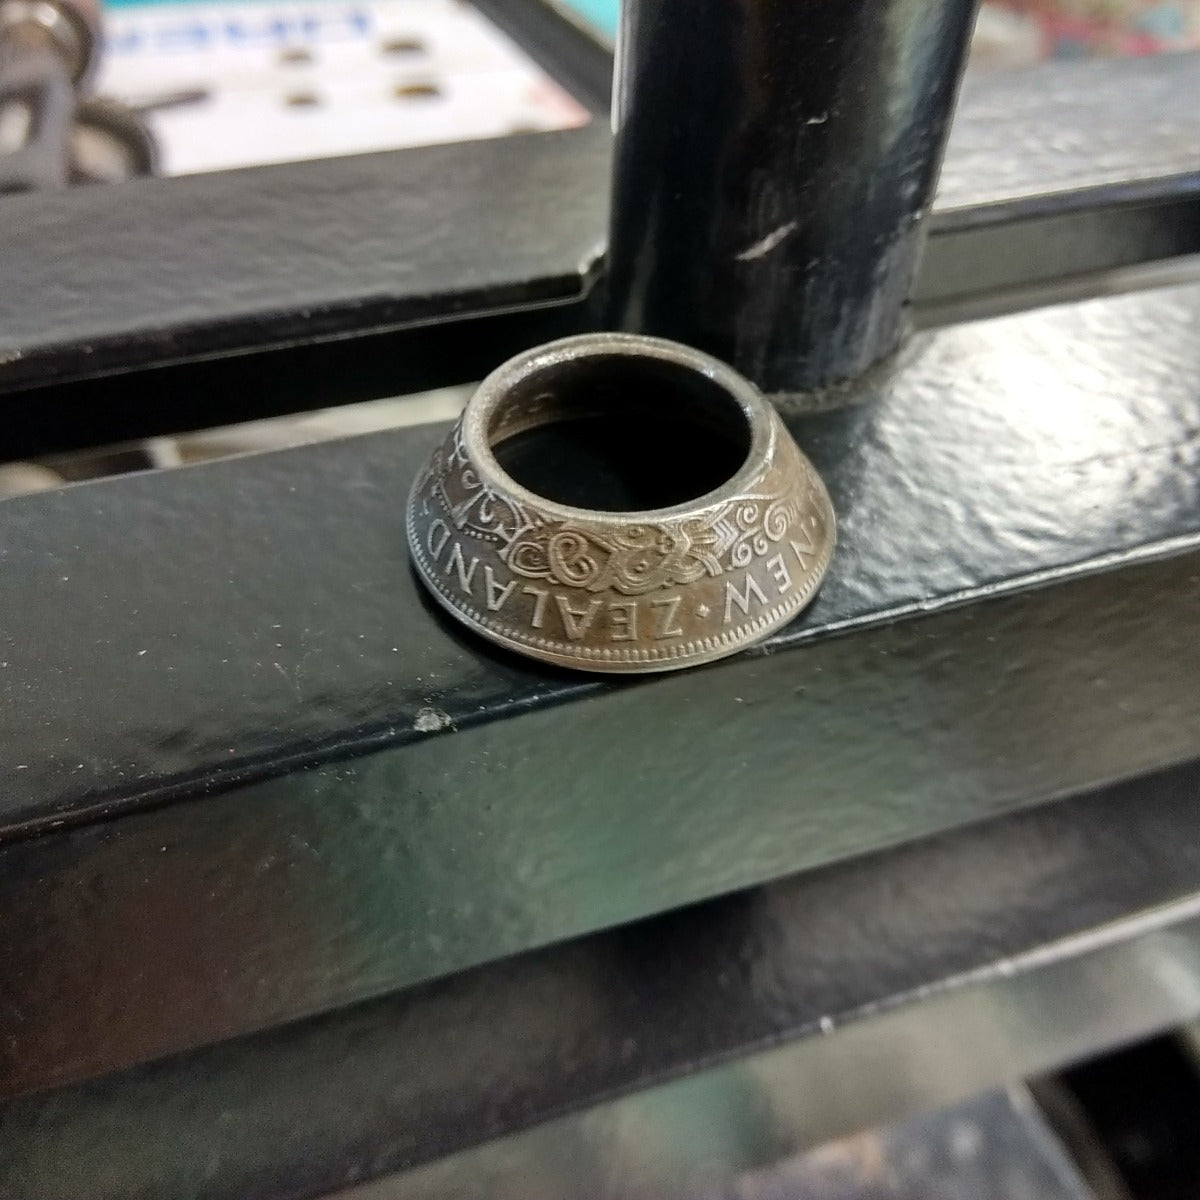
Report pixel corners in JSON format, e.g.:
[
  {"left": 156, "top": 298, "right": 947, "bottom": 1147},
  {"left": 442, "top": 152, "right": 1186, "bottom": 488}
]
[{"left": 407, "top": 334, "right": 835, "bottom": 673}]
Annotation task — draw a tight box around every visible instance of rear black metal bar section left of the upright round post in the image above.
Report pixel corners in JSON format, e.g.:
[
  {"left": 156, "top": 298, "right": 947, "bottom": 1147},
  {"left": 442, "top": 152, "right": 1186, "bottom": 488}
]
[{"left": 0, "top": 128, "right": 607, "bottom": 398}]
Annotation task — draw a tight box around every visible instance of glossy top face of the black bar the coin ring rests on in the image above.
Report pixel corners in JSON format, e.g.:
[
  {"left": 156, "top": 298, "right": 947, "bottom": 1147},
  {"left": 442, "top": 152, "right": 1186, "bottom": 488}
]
[{"left": 9, "top": 278, "right": 1200, "bottom": 844}]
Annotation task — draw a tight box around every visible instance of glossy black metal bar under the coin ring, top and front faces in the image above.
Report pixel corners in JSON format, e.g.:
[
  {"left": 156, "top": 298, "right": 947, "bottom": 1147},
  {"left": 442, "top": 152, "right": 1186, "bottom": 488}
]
[{"left": 0, "top": 278, "right": 1200, "bottom": 1091}]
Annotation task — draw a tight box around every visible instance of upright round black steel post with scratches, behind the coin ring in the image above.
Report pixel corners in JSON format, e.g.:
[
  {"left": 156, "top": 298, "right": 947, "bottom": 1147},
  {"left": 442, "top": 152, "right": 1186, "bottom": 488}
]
[{"left": 607, "top": 0, "right": 976, "bottom": 392}]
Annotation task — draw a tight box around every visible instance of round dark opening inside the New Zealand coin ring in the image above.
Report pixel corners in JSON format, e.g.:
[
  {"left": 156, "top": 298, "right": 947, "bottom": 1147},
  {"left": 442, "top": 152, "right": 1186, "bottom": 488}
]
[{"left": 488, "top": 355, "right": 750, "bottom": 512}]
